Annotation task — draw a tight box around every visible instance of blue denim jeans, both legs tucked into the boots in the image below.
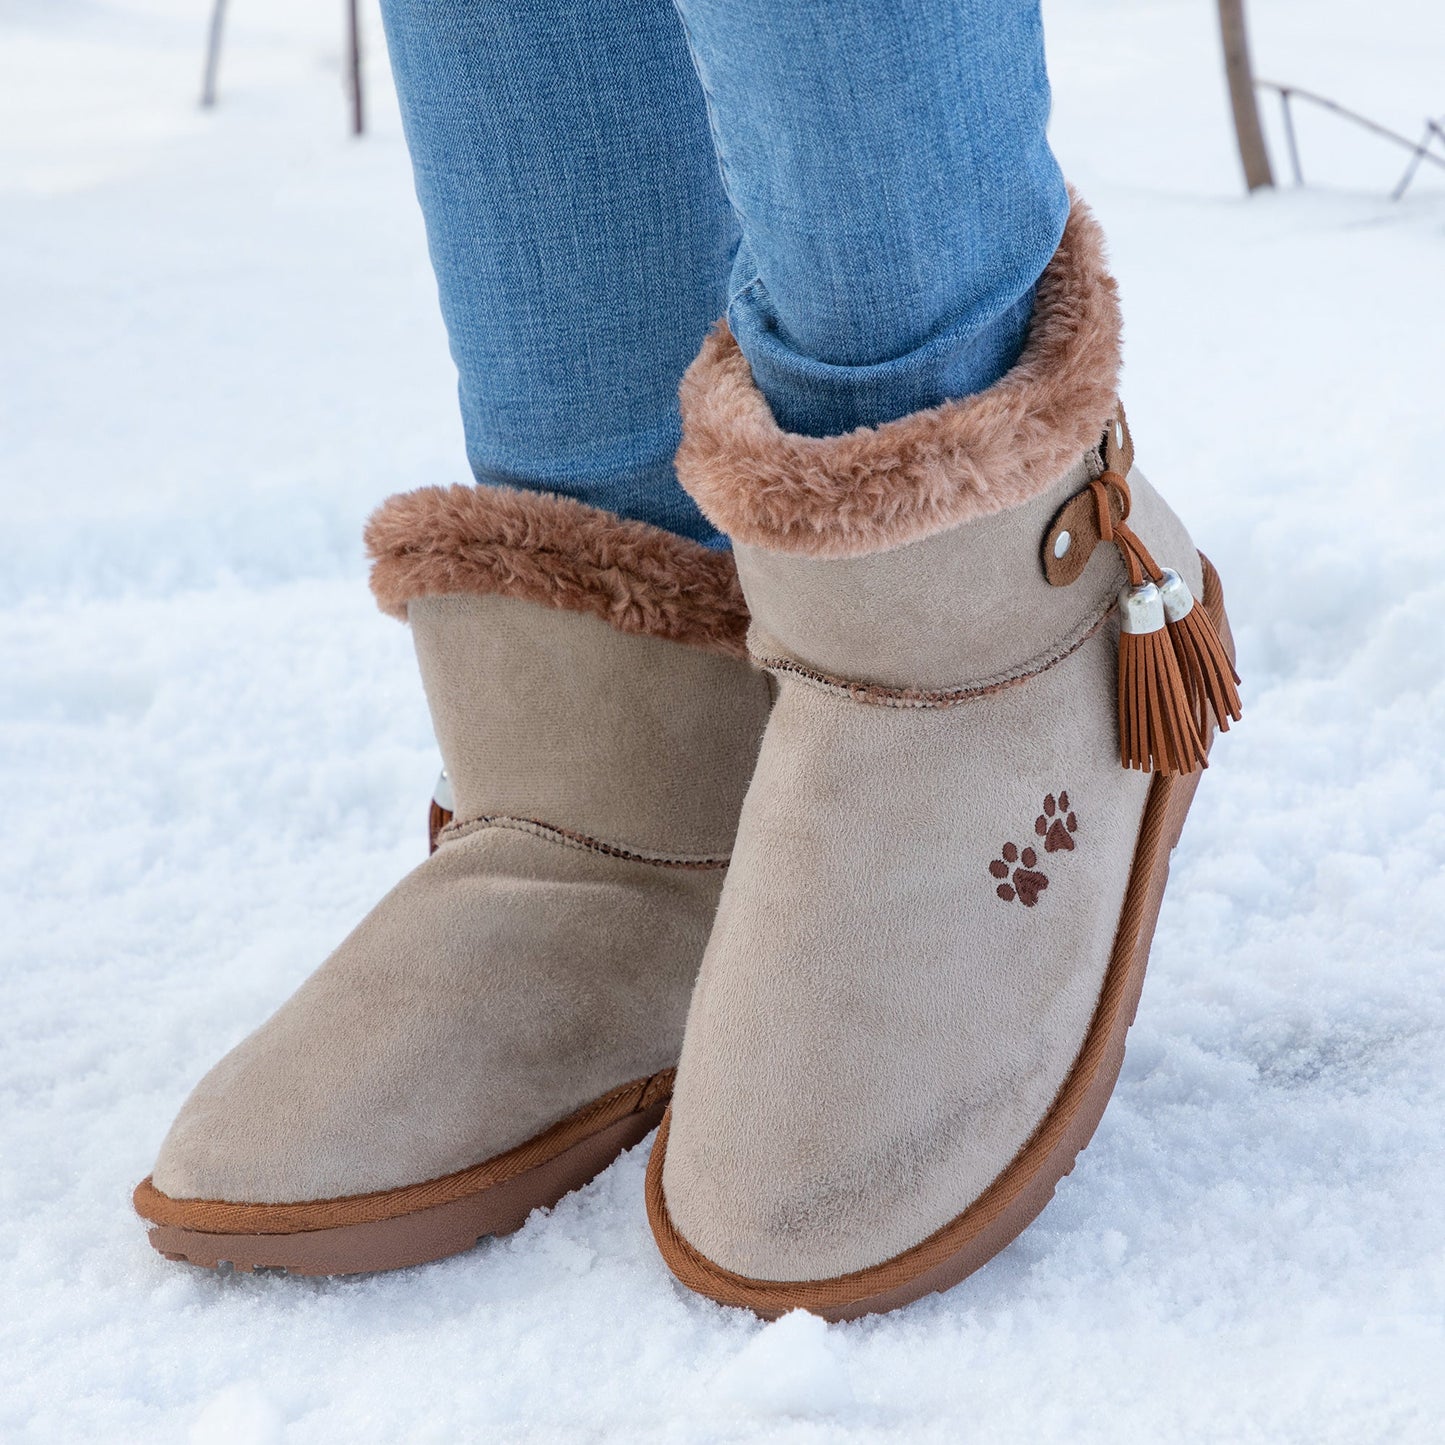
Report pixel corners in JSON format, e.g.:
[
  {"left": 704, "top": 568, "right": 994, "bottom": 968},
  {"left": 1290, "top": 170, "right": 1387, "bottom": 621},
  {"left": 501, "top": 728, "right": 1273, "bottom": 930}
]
[{"left": 381, "top": 0, "right": 1068, "bottom": 546}]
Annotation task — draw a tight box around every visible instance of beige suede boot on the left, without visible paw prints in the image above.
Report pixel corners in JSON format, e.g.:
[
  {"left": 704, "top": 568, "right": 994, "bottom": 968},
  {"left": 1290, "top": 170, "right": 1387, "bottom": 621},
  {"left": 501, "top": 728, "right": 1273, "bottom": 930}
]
[{"left": 136, "top": 487, "right": 769, "bottom": 1274}]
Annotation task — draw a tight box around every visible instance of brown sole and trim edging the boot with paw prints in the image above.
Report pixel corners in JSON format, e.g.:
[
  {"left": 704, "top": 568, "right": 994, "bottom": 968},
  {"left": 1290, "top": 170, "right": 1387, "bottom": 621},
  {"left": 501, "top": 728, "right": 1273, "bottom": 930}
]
[{"left": 646, "top": 553, "right": 1234, "bottom": 1319}]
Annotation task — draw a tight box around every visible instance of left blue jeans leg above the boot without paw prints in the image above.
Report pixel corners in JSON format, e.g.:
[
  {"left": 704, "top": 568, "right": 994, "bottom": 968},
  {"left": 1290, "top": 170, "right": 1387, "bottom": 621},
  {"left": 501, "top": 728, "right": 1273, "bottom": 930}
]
[{"left": 381, "top": 0, "right": 737, "bottom": 545}]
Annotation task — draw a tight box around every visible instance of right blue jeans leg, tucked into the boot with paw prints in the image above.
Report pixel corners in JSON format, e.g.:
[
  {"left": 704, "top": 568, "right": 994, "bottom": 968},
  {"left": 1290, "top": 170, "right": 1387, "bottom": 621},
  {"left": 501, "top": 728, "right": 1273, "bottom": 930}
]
[{"left": 676, "top": 0, "right": 1068, "bottom": 436}]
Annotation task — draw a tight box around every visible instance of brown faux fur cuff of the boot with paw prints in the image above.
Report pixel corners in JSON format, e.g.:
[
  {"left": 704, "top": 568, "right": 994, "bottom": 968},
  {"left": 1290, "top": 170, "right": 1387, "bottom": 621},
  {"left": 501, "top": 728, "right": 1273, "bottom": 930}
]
[{"left": 678, "top": 197, "right": 1120, "bottom": 556}]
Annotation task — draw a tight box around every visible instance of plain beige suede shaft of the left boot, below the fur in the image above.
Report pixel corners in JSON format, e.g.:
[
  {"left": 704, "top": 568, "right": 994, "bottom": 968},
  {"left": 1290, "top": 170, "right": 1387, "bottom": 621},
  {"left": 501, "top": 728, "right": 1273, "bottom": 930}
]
[{"left": 407, "top": 594, "right": 767, "bottom": 858}]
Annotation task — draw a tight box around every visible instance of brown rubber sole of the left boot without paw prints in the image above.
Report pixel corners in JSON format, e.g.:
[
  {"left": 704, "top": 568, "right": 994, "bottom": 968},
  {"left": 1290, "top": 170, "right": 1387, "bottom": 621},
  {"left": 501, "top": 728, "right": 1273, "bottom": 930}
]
[{"left": 134, "top": 1069, "right": 673, "bottom": 1274}]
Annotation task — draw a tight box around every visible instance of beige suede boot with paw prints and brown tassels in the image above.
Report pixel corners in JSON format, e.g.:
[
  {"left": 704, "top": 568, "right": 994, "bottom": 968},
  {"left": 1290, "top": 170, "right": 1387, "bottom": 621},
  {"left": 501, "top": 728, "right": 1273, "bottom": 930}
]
[{"left": 647, "top": 204, "right": 1238, "bottom": 1319}]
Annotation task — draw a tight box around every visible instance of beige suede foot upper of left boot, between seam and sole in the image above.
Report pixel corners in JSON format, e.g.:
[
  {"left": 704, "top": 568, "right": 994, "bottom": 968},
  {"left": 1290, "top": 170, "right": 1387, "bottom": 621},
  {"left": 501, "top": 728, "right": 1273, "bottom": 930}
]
[{"left": 142, "top": 829, "right": 715, "bottom": 1204}]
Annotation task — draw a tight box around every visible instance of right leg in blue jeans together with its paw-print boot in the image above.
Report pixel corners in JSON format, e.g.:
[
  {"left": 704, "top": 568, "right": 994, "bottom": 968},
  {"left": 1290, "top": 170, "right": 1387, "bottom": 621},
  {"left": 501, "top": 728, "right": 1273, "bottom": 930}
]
[{"left": 646, "top": 0, "right": 1240, "bottom": 1319}]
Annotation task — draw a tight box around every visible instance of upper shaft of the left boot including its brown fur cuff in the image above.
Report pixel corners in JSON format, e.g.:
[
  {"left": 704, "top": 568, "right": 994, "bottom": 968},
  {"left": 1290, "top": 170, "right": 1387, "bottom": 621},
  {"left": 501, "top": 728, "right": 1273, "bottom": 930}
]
[{"left": 367, "top": 487, "right": 769, "bottom": 861}]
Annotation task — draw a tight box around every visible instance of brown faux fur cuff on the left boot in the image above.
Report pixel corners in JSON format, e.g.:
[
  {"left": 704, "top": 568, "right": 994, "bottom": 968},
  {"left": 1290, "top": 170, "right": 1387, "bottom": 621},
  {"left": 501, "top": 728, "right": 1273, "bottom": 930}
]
[{"left": 366, "top": 486, "right": 747, "bottom": 657}]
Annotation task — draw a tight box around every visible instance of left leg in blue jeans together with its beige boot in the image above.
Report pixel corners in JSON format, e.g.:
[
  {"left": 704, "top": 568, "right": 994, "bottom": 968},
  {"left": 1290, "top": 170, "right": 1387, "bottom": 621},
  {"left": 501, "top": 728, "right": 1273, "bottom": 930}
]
[{"left": 134, "top": 0, "right": 770, "bottom": 1274}]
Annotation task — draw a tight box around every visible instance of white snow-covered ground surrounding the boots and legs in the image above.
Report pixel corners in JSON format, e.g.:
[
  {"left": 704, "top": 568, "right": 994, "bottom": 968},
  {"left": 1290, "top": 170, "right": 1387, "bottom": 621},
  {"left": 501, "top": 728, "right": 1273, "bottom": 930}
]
[{"left": 0, "top": 0, "right": 1445, "bottom": 1445}]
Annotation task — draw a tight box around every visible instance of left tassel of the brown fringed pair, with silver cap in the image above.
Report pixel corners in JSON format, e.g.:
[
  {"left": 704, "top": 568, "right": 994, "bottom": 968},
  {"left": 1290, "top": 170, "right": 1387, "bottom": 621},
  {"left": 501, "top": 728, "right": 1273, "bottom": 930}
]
[{"left": 1118, "top": 581, "right": 1209, "bottom": 773}]
